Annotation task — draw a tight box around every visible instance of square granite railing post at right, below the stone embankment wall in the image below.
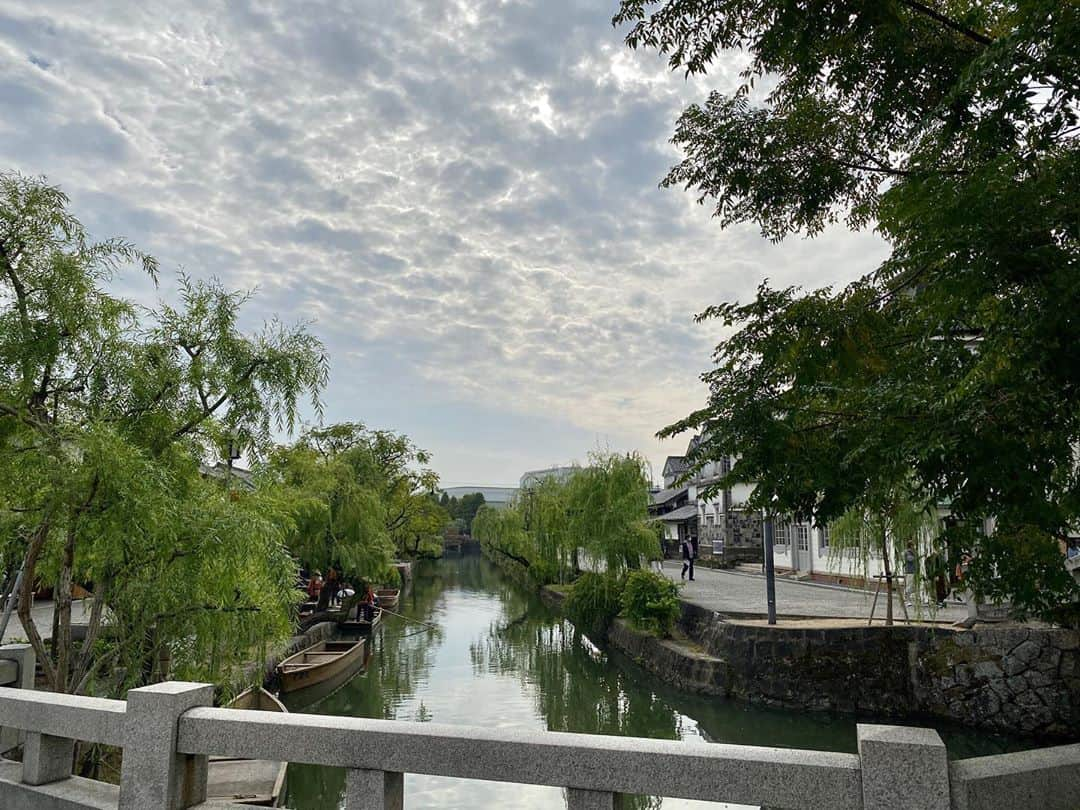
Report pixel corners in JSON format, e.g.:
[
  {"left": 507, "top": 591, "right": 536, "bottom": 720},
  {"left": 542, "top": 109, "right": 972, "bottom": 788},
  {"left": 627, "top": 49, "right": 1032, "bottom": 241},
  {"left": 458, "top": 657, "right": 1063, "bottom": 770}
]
[{"left": 856, "top": 723, "right": 949, "bottom": 810}]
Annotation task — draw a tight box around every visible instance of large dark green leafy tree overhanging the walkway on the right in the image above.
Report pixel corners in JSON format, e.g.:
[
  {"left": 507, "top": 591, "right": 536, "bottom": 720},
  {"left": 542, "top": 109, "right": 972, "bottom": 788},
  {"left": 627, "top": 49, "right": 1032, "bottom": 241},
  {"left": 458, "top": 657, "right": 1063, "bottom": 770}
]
[{"left": 616, "top": 0, "right": 1080, "bottom": 613}]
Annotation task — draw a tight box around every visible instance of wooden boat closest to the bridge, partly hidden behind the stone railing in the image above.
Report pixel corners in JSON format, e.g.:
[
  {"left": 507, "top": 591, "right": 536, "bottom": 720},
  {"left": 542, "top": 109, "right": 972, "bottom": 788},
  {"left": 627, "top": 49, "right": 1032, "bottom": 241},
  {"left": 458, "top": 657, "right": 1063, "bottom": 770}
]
[{"left": 206, "top": 688, "right": 288, "bottom": 807}]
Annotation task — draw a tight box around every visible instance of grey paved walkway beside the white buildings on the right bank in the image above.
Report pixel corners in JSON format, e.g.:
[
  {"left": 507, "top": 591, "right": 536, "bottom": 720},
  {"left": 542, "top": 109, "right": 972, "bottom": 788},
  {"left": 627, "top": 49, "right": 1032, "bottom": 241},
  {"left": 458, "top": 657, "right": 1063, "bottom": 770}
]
[{"left": 664, "top": 559, "right": 968, "bottom": 624}]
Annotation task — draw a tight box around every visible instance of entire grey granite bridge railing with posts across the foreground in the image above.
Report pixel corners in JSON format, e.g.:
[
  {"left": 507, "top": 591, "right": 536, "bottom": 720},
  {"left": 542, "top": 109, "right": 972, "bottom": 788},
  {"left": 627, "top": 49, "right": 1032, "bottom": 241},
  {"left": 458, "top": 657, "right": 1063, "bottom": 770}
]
[{"left": 0, "top": 652, "right": 1080, "bottom": 810}]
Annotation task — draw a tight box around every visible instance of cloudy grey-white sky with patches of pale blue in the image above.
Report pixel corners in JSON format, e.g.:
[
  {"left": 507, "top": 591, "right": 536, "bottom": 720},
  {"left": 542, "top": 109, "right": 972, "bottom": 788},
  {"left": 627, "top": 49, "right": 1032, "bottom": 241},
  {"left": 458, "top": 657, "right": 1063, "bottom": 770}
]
[{"left": 0, "top": 0, "right": 883, "bottom": 486}]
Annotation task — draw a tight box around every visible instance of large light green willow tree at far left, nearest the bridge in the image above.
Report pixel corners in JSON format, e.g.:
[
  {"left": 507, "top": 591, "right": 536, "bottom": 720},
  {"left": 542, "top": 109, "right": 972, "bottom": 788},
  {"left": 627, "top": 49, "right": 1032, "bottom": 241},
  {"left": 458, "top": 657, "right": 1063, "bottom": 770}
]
[{"left": 0, "top": 174, "right": 326, "bottom": 692}]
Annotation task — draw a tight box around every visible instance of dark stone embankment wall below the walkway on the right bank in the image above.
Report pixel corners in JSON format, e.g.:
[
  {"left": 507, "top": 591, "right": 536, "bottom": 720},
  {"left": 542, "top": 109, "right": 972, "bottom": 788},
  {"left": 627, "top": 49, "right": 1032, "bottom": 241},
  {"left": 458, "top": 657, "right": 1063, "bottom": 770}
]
[{"left": 681, "top": 603, "right": 1080, "bottom": 739}]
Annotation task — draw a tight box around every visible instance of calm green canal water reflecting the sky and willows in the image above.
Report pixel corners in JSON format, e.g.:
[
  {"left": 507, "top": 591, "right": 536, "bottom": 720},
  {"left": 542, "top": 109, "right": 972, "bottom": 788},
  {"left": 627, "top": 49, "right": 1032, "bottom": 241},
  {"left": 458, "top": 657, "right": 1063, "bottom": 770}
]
[{"left": 286, "top": 556, "right": 1026, "bottom": 810}]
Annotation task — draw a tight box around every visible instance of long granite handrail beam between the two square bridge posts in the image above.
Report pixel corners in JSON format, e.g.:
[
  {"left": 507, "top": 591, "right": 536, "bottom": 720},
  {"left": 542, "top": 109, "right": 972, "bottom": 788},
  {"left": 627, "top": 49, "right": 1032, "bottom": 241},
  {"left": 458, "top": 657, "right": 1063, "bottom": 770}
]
[{"left": 177, "top": 708, "right": 861, "bottom": 810}]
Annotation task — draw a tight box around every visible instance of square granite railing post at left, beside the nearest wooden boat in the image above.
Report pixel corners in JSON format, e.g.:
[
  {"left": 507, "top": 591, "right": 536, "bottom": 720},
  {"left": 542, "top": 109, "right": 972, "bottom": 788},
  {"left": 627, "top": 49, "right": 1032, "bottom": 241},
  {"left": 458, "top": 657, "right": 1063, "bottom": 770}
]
[{"left": 119, "top": 681, "right": 214, "bottom": 810}]
